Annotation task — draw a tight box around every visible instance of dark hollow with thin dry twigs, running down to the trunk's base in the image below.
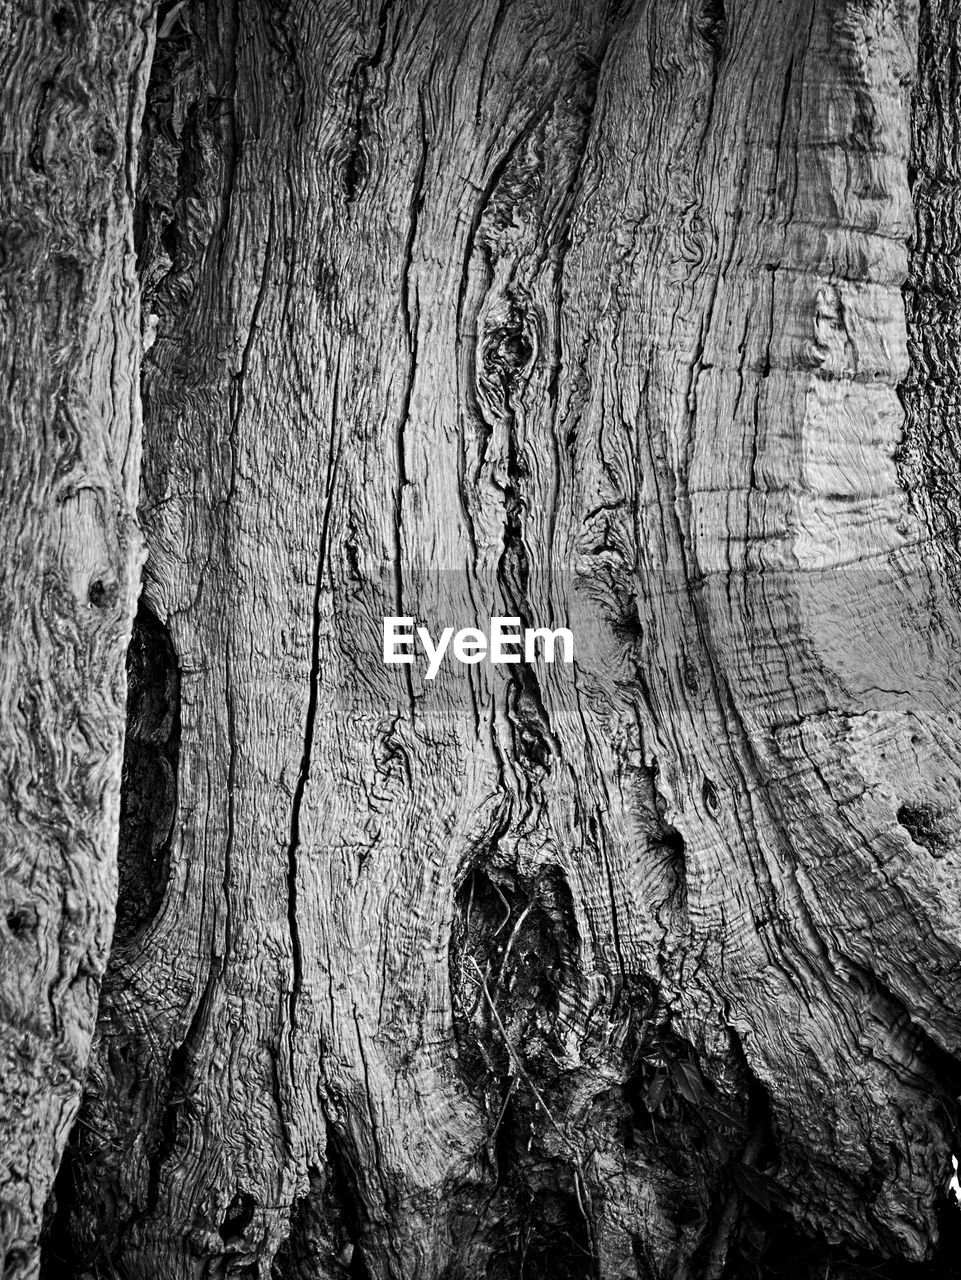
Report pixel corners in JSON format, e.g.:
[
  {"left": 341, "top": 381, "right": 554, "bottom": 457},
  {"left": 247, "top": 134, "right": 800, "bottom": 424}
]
[{"left": 450, "top": 865, "right": 596, "bottom": 1280}]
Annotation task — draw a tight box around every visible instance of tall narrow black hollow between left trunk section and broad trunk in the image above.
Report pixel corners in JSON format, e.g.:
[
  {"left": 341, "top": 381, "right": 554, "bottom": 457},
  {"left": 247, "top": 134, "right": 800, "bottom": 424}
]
[{"left": 115, "top": 604, "right": 180, "bottom": 942}]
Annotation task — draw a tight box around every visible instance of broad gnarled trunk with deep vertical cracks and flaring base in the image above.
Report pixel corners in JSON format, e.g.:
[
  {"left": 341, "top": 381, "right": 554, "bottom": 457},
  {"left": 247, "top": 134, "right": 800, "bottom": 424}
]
[{"left": 5, "top": 0, "right": 961, "bottom": 1280}]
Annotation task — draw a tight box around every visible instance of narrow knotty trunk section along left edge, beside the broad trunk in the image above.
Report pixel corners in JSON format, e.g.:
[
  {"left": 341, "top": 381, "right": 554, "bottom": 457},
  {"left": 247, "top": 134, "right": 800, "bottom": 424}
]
[{"left": 0, "top": 0, "right": 152, "bottom": 1280}]
